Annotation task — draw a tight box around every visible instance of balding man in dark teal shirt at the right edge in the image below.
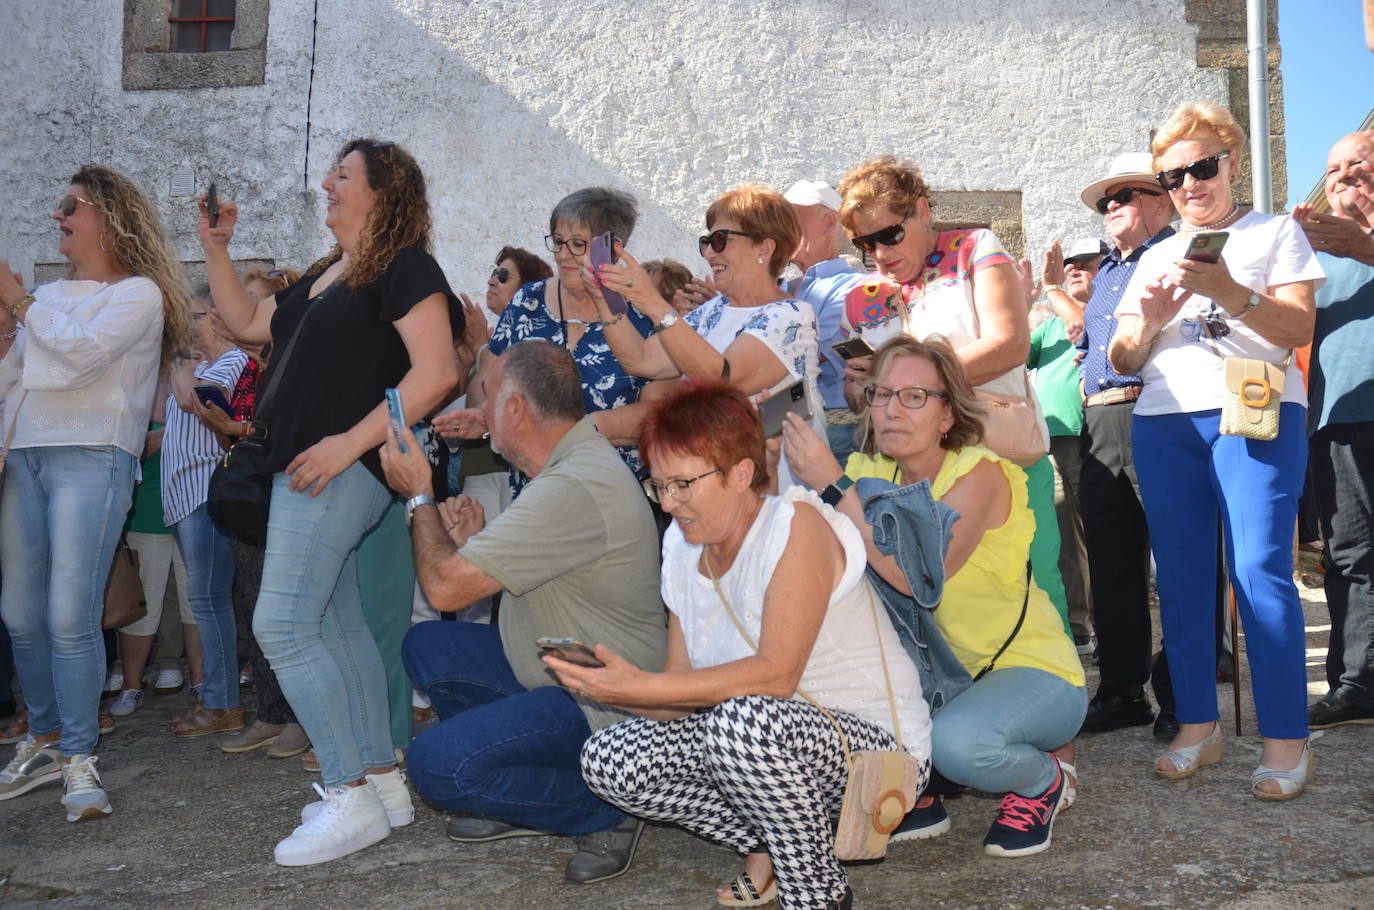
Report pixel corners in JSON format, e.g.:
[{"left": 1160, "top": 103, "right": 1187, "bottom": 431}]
[{"left": 1293, "top": 131, "right": 1374, "bottom": 730}]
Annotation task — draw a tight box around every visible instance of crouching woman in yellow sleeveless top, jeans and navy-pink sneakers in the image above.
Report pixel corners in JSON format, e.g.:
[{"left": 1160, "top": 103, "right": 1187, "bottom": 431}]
[{"left": 783, "top": 335, "right": 1088, "bottom": 856}]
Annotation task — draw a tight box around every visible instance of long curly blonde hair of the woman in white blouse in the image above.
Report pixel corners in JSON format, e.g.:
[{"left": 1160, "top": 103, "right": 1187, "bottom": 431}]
[{"left": 69, "top": 164, "right": 191, "bottom": 367}]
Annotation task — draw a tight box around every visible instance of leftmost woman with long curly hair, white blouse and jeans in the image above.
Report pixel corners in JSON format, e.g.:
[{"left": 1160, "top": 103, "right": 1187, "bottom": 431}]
[{"left": 0, "top": 165, "right": 190, "bottom": 822}]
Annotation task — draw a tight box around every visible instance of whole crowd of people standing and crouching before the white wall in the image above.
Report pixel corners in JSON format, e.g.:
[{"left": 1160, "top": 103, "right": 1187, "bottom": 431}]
[{"left": 0, "top": 103, "right": 1374, "bottom": 909}]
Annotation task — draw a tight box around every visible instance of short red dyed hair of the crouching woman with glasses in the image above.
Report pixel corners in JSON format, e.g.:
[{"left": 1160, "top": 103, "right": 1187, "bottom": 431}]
[{"left": 639, "top": 382, "right": 768, "bottom": 492}]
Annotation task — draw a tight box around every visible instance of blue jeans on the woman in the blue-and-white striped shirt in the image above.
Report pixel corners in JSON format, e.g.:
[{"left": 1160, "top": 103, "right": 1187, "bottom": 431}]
[{"left": 172, "top": 503, "right": 239, "bottom": 708}]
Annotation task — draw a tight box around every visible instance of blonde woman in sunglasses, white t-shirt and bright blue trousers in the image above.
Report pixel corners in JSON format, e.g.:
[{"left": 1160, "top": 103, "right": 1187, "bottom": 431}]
[{"left": 1107, "top": 103, "right": 1325, "bottom": 800}]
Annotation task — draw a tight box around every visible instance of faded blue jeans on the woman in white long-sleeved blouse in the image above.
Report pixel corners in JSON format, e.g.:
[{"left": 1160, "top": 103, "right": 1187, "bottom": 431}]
[{"left": 0, "top": 445, "right": 135, "bottom": 756}]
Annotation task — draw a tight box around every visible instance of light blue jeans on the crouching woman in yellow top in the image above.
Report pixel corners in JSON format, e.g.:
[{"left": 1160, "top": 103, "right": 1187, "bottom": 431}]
[{"left": 930, "top": 667, "right": 1088, "bottom": 796}]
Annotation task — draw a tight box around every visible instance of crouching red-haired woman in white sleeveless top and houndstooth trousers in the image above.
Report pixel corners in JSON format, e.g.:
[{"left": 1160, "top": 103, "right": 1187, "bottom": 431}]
[{"left": 545, "top": 382, "right": 930, "bottom": 909}]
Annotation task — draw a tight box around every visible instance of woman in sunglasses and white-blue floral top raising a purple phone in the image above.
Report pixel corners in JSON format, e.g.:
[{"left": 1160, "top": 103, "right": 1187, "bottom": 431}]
[{"left": 588, "top": 186, "right": 824, "bottom": 488}]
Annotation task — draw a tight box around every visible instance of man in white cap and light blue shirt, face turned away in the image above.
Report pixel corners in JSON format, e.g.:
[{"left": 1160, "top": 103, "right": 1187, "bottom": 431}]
[{"left": 783, "top": 180, "right": 863, "bottom": 465}]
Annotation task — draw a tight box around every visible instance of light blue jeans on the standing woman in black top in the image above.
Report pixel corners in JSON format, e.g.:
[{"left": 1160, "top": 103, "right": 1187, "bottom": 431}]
[{"left": 253, "top": 462, "right": 395, "bottom": 786}]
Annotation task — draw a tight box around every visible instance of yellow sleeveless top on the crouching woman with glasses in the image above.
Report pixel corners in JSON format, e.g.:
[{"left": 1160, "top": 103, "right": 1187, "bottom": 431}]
[{"left": 845, "top": 445, "right": 1085, "bottom": 686}]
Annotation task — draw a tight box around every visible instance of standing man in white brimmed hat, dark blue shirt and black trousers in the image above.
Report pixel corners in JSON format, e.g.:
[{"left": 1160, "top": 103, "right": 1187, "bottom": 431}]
[{"left": 1077, "top": 153, "right": 1178, "bottom": 738}]
